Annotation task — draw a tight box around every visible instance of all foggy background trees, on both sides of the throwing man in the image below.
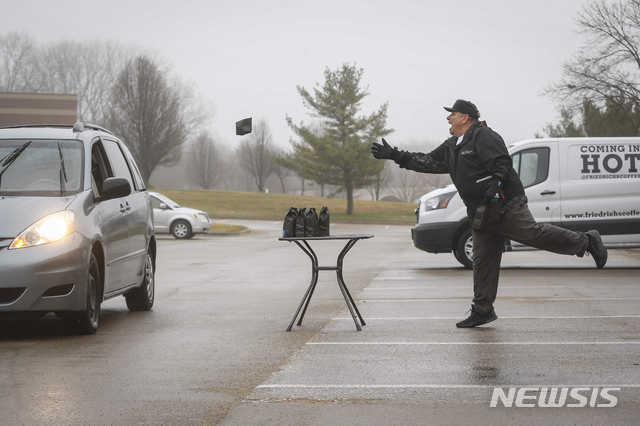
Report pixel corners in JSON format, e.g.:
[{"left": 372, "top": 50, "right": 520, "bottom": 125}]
[{"left": 0, "top": 0, "right": 640, "bottom": 208}]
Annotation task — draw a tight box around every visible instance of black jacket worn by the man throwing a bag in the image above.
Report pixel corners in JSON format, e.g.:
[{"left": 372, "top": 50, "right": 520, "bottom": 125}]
[{"left": 396, "top": 122, "right": 524, "bottom": 217}]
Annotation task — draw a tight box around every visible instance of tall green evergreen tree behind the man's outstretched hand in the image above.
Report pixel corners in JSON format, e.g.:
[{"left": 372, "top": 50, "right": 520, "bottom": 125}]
[{"left": 281, "top": 64, "right": 393, "bottom": 214}]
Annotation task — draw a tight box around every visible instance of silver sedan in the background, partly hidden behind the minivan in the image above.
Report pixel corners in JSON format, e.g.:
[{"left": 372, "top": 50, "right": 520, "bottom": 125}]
[{"left": 149, "top": 192, "right": 211, "bottom": 239}]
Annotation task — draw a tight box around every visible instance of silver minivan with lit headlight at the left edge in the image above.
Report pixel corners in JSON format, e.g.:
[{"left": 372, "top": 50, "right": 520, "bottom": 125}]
[{"left": 0, "top": 123, "right": 156, "bottom": 333}]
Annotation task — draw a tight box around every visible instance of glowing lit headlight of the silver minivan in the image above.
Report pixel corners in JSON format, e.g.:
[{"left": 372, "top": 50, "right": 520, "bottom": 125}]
[{"left": 9, "top": 210, "right": 75, "bottom": 250}]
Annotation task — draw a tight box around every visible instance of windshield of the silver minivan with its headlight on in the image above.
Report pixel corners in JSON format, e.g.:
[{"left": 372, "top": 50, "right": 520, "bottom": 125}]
[{"left": 0, "top": 139, "right": 84, "bottom": 197}]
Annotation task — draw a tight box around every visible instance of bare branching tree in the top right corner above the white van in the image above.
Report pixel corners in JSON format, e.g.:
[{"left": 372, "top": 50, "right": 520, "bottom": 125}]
[{"left": 547, "top": 0, "right": 640, "bottom": 112}]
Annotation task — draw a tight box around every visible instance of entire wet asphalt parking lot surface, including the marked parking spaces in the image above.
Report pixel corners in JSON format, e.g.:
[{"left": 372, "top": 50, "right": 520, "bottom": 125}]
[{"left": 0, "top": 221, "right": 640, "bottom": 425}]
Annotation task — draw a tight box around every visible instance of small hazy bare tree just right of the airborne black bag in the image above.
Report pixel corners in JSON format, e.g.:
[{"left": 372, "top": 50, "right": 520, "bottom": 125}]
[{"left": 238, "top": 120, "right": 274, "bottom": 192}]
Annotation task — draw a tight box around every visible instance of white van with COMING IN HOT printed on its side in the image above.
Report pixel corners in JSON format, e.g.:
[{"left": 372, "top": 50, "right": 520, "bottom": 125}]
[{"left": 411, "top": 137, "right": 640, "bottom": 268}]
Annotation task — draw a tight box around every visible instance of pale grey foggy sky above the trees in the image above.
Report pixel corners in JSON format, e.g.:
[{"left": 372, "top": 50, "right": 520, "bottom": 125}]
[{"left": 0, "top": 0, "right": 586, "bottom": 147}]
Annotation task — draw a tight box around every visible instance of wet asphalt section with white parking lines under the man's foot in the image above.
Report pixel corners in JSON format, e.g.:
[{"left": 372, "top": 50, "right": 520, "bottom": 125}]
[{"left": 224, "top": 221, "right": 640, "bottom": 425}]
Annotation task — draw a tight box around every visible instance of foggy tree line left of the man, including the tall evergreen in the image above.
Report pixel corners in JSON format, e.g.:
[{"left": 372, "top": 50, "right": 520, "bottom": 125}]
[{"left": 0, "top": 33, "right": 446, "bottom": 205}]
